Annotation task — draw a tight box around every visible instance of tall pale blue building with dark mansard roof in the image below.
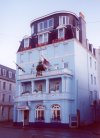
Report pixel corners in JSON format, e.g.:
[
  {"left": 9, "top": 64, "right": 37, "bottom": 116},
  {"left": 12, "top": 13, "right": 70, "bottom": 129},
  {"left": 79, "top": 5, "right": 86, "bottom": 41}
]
[{"left": 13, "top": 11, "right": 98, "bottom": 125}]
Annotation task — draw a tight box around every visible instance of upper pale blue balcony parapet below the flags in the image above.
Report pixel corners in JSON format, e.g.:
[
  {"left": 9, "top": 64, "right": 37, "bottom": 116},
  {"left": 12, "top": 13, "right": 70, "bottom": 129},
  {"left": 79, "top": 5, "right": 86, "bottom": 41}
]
[{"left": 18, "top": 68, "right": 72, "bottom": 80}]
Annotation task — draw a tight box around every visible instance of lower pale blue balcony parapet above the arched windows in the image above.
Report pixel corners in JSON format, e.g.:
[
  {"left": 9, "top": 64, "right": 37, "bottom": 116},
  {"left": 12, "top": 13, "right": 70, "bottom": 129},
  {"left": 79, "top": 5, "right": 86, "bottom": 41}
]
[{"left": 14, "top": 92, "right": 75, "bottom": 102}]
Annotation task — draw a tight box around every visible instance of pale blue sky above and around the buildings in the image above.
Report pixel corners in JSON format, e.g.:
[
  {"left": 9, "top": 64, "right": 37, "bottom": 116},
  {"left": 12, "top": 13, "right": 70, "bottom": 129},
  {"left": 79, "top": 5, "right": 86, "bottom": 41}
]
[{"left": 0, "top": 0, "right": 100, "bottom": 68}]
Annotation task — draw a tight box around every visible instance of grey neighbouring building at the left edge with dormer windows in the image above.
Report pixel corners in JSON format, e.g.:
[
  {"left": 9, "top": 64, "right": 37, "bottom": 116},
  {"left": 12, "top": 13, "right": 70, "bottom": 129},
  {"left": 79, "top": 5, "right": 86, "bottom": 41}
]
[{"left": 0, "top": 65, "right": 16, "bottom": 121}]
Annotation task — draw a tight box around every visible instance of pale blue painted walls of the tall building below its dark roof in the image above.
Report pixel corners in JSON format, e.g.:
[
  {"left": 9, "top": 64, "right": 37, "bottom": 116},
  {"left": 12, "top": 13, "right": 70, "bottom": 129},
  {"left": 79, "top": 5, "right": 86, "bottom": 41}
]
[{"left": 14, "top": 11, "right": 98, "bottom": 125}]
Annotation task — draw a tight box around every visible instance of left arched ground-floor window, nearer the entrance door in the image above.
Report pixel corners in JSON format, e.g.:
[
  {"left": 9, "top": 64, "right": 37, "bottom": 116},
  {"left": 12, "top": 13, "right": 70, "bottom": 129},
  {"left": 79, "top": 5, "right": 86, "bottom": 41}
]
[{"left": 35, "top": 105, "right": 45, "bottom": 121}]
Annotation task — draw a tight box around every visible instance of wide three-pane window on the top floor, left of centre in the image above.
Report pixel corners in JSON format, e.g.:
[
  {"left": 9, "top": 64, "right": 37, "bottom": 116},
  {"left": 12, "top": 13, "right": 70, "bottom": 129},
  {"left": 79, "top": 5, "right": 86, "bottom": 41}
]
[{"left": 38, "top": 18, "right": 53, "bottom": 32}]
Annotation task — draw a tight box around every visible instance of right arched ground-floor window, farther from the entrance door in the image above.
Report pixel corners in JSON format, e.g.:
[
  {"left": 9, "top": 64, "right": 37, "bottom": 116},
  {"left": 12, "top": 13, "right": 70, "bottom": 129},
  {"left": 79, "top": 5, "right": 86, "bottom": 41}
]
[{"left": 51, "top": 104, "right": 61, "bottom": 121}]
